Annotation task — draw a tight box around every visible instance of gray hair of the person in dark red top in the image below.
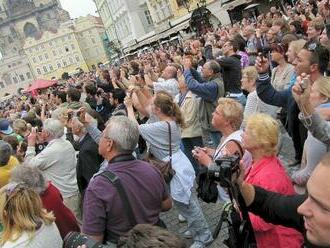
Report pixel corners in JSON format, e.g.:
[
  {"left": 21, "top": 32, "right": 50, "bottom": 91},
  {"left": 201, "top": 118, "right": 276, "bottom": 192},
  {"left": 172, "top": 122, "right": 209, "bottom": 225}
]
[{"left": 10, "top": 164, "right": 47, "bottom": 194}]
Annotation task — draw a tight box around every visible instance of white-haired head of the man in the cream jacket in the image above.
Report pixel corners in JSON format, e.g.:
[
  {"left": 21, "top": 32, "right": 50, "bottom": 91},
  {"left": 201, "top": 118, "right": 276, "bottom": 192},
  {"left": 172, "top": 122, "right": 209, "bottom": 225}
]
[{"left": 42, "top": 118, "right": 64, "bottom": 142}]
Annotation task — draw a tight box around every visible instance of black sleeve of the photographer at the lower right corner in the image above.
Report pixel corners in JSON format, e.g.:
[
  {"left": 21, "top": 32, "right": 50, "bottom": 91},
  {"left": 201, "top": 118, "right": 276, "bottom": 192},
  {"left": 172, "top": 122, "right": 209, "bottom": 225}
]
[{"left": 248, "top": 186, "right": 317, "bottom": 248}]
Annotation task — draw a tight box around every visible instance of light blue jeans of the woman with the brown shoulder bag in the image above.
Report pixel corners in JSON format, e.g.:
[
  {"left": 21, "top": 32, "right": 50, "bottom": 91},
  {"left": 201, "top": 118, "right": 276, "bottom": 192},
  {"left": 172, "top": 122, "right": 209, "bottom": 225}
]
[{"left": 173, "top": 193, "right": 212, "bottom": 244}]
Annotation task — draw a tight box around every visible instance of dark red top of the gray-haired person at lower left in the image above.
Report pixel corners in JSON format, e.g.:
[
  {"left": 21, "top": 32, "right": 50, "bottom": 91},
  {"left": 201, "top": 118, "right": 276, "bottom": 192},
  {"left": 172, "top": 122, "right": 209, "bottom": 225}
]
[{"left": 40, "top": 182, "right": 80, "bottom": 239}]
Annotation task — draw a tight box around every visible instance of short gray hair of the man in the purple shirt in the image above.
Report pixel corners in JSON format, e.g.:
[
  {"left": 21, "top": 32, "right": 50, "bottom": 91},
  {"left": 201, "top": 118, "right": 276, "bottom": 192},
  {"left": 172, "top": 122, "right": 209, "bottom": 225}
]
[{"left": 105, "top": 116, "right": 139, "bottom": 153}]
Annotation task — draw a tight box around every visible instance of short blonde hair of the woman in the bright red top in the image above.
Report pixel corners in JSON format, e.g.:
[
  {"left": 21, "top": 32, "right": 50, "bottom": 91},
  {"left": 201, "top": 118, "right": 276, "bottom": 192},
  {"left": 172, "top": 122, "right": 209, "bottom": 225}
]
[{"left": 246, "top": 114, "right": 279, "bottom": 156}]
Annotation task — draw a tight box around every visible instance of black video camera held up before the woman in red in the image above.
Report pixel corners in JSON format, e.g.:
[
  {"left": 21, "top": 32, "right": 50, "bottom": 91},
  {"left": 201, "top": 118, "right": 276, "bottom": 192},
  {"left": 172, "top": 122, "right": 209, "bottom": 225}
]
[{"left": 207, "top": 154, "right": 241, "bottom": 188}]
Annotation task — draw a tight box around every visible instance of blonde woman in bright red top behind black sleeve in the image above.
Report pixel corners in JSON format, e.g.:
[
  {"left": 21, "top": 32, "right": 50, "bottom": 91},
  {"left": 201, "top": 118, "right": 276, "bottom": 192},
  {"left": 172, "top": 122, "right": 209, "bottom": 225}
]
[{"left": 242, "top": 114, "right": 303, "bottom": 248}]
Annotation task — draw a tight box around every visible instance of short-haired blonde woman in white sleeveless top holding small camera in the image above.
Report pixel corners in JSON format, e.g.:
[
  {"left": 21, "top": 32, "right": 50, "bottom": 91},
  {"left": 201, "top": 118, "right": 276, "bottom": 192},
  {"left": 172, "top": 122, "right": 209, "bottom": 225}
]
[{"left": 193, "top": 98, "right": 250, "bottom": 202}]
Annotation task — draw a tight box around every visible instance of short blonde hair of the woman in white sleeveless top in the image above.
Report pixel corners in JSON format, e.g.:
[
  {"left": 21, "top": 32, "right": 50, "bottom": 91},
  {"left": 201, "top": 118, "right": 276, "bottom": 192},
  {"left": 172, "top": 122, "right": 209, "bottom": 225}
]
[{"left": 218, "top": 97, "right": 243, "bottom": 130}]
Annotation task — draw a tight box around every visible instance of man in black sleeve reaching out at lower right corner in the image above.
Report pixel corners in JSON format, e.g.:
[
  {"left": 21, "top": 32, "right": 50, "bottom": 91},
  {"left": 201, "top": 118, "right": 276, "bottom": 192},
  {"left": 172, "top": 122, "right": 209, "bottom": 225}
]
[{"left": 237, "top": 153, "right": 330, "bottom": 247}]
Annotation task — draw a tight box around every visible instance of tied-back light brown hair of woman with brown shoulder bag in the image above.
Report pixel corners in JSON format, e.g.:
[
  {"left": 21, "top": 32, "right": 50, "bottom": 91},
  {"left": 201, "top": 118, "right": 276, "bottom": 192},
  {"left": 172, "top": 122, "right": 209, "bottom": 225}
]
[{"left": 154, "top": 91, "right": 185, "bottom": 127}]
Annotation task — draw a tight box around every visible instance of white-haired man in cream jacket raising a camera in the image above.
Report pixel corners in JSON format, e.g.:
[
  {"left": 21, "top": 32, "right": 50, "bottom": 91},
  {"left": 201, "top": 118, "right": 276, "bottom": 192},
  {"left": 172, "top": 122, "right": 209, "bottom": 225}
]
[{"left": 25, "top": 119, "right": 79, "bottom": 216}]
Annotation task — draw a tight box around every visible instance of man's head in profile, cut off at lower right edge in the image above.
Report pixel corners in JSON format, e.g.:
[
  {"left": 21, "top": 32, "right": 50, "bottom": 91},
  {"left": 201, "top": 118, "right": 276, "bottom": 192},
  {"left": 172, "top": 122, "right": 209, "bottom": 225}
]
[{"left": 298, "top": 153, "right": 330, "bottom": 247}]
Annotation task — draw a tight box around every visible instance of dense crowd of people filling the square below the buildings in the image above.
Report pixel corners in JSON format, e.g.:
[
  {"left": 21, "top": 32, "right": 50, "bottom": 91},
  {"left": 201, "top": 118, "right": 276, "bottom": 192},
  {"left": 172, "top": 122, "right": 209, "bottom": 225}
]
[{"left": 0, "top": 0, "right": 330, "bottom": 248}]
